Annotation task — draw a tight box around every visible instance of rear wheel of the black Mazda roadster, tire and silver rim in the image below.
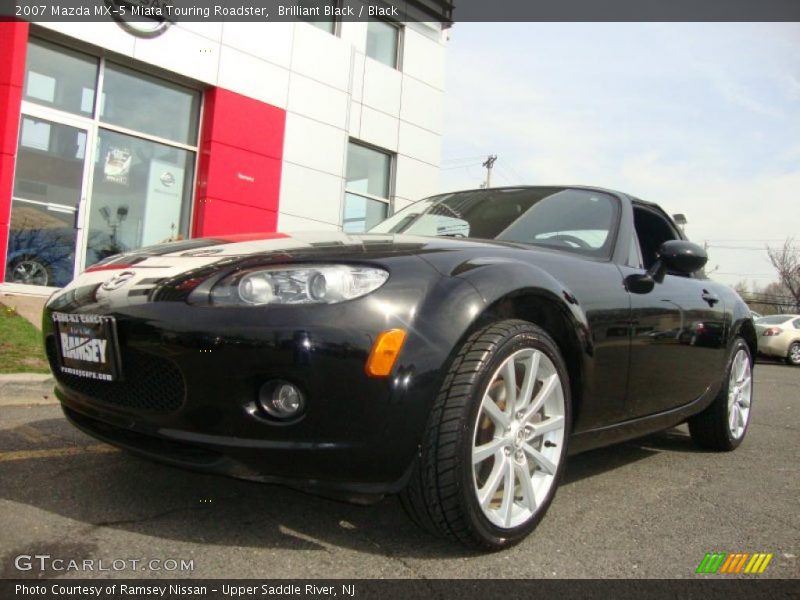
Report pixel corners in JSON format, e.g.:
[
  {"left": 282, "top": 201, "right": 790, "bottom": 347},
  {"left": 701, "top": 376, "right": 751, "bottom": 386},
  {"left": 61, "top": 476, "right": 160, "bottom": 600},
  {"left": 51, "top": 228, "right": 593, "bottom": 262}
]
[{"left": 689, "top": 337, "right": 753, "bottom": 451}]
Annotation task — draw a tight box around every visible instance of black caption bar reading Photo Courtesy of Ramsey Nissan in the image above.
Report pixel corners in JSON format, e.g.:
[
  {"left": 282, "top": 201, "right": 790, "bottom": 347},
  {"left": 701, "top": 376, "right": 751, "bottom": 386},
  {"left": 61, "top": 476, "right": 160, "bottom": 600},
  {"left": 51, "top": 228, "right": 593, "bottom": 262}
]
[{"left": 0, "top": 578, "right": 797, "bottom": 600}]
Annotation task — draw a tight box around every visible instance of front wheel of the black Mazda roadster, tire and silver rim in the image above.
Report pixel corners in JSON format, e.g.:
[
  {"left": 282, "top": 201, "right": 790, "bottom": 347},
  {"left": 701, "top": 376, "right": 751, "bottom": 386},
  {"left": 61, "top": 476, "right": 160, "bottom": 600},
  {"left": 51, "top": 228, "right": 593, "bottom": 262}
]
[{"left": 401, "top": 320, "right": 571, "bottom": 550}]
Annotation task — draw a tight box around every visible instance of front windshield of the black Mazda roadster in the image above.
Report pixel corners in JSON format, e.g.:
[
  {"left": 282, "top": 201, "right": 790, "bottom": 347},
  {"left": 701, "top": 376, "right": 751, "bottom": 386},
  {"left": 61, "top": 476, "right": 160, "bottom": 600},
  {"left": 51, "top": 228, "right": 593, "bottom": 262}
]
[{"left": 369, "top": 187, "right": 619, "bottom": 256}]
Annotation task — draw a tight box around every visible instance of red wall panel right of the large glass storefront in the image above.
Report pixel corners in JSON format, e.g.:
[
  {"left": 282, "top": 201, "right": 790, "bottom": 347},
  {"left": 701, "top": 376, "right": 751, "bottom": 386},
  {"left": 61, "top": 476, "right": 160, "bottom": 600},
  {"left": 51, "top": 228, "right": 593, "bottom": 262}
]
[{"left": 192, "top": 88, "right": 286, "bottom": 237}]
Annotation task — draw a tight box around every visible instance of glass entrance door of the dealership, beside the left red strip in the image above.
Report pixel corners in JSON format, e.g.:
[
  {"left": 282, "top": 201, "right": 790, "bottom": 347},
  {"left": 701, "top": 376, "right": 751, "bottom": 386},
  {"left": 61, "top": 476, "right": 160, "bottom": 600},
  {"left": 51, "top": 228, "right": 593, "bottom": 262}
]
[{"left": 6, "top": 114, "right": 91, "bottom": 287}]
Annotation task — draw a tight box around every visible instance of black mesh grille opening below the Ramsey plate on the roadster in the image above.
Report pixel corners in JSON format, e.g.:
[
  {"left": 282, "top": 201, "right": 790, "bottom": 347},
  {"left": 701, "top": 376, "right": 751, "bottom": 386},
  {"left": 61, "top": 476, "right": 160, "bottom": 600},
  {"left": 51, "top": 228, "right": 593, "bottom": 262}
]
[{"left": 46, "top": 336, "right": 186, "bottom": 413}]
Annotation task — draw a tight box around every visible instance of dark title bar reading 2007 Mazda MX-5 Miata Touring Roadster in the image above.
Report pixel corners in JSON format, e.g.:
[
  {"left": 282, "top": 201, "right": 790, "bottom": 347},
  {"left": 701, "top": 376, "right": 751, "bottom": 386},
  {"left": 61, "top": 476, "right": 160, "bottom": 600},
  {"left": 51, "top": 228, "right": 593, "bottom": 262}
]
[{"left": 0, "top": 0, "right": 800, "bottom": 25}]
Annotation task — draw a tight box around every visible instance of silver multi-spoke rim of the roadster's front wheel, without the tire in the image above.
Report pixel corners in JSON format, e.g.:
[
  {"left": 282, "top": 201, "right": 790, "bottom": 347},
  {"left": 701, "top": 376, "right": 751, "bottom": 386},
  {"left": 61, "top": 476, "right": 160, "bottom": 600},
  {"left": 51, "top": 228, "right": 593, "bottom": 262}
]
[{"left": 472, "top": 349, "right": 565, "bottom": 528}]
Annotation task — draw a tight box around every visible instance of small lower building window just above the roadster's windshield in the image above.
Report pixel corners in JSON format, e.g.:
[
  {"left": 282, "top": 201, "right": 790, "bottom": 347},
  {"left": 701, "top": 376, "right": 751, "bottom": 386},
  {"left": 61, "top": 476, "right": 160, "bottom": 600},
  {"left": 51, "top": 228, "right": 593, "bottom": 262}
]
[{"left": 342, "top": 142, "right": 392, "bottom": 233}]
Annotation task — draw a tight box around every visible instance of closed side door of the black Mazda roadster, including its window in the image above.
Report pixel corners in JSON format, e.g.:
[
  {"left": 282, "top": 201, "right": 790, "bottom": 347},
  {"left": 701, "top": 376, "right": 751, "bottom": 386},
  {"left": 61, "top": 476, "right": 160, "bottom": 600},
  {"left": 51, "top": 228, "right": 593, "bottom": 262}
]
[{"left": 621, "top": 206, "right": 727, "bottom": 417}]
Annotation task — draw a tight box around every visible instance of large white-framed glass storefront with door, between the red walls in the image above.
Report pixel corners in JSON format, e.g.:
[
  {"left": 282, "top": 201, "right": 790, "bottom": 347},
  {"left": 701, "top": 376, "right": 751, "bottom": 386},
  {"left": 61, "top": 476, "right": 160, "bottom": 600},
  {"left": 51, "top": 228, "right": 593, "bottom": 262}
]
[{"left": 6, "top": 39, "right": 200, "bottom": 287}]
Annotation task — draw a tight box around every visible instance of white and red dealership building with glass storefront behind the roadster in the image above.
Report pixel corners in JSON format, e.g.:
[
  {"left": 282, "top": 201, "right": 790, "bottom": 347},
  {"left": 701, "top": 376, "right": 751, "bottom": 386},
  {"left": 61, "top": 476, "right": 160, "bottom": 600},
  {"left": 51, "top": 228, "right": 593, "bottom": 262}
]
[{"left": 0, "top": 7, "right": 449, "bottom": 293}]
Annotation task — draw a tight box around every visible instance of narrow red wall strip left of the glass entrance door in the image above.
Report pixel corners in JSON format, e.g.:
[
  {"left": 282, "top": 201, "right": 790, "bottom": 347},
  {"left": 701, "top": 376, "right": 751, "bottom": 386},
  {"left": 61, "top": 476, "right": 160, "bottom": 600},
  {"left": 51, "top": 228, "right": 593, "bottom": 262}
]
[{"left": 0, "top": 21, "right": 29, "bottom": 281}]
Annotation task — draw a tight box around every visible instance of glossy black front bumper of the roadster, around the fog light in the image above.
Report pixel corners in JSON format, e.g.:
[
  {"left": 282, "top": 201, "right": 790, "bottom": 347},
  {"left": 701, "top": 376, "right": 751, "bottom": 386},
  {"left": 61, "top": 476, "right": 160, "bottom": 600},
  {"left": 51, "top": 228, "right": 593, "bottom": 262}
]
[{"left": 43, "top": 266, "right": 488, "bottom": 494}]
